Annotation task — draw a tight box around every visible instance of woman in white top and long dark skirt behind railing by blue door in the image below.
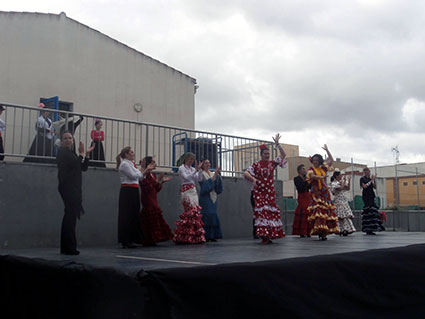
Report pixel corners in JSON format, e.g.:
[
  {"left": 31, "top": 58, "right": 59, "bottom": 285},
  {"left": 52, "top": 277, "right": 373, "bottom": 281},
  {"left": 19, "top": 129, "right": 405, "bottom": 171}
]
[{"left": 24, "top": 103, "right": 54, "bottom": 163}]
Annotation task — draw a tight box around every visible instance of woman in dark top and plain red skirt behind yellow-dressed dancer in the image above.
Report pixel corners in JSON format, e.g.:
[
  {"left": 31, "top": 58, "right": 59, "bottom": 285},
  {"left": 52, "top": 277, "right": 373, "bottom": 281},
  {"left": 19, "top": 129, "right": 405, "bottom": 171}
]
[{"left": 292, "top": 164, "right": 311, "bottom": 237}]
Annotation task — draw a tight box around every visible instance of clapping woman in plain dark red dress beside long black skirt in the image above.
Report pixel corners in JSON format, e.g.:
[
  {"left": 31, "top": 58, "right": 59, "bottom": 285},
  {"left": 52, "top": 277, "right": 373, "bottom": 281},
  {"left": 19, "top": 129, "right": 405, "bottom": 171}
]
[{"left": 140, "top": 156, "right": 173, "bottom": 246}]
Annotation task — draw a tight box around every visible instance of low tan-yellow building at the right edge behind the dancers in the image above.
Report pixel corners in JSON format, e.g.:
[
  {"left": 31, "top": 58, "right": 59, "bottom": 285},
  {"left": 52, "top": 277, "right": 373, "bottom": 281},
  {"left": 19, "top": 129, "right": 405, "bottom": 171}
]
[{"left": 386, "top": 175, "right": 425, "bottom": 207}]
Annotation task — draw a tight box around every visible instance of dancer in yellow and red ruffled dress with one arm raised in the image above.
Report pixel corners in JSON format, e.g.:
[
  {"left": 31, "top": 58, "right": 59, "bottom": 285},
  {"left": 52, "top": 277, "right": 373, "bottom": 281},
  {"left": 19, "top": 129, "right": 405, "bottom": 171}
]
[{"left": 307, "top": 144, "right": 339, "bottom": 240}]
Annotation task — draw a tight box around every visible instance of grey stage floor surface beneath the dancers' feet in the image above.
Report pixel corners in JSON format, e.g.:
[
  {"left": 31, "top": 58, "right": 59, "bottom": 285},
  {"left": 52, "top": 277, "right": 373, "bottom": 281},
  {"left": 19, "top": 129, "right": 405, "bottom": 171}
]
[{"left": 0, "top": 231, "right": 425, "bottom": 273}]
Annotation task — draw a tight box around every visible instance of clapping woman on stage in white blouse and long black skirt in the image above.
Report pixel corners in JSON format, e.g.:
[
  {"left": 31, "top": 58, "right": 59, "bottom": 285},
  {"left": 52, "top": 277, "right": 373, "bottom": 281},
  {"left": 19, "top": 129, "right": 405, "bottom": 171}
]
[{"left": 116, "top": 146, "right": 154, "bottom": 248}]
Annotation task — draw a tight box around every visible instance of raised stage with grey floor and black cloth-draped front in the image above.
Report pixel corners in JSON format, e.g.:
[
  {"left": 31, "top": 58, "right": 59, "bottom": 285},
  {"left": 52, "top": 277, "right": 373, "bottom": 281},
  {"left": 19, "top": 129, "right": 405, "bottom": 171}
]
[{"left": 0, "top": 231, "right": 425, "bottom": 319}]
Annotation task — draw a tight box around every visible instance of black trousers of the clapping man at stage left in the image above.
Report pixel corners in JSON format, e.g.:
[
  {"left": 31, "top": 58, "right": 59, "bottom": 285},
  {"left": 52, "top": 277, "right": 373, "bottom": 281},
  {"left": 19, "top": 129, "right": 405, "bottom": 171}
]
[{"left": 61, "top": 193, "right": 81, "bottom": 252}]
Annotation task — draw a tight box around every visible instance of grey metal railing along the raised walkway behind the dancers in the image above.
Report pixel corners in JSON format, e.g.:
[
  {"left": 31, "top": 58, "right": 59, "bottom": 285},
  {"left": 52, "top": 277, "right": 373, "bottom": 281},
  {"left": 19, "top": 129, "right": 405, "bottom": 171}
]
[{"left": 0, "top": 103, "right": 277, "bottom": 177}]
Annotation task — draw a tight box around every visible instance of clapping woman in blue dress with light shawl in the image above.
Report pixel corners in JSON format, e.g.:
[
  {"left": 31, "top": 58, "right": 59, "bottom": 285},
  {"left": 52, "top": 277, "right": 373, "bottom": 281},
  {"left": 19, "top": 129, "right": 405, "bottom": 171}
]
[{"left": 199, "top": 159, "right": 223, "bottom": 242}]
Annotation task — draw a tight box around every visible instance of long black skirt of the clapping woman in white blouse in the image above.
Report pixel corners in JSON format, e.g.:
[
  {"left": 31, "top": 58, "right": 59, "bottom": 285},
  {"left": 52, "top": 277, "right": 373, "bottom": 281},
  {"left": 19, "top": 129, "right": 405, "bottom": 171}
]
[{"left": 118, "top": 187, "right": 143, "bottom": 244}]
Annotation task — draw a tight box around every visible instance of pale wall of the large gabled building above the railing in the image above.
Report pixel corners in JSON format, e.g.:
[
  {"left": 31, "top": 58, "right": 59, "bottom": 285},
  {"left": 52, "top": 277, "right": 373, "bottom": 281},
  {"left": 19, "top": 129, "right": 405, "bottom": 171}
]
[{"left": 0, "top": 12, "right": 196, "bottom": 128}]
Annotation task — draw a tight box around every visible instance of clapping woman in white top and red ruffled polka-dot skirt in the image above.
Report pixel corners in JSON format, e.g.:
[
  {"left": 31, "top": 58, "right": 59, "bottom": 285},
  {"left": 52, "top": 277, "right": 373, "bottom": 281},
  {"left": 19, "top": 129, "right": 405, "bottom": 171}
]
[{"left": 173, "top": 152, "right": 205, "bottom": 244}]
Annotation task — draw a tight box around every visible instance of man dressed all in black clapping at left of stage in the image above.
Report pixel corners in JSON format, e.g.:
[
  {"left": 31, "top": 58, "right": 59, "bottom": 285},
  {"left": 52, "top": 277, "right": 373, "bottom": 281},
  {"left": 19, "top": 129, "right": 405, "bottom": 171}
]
[{"left": 56, "top": 131, "right": 93, "bottom": 255}]
